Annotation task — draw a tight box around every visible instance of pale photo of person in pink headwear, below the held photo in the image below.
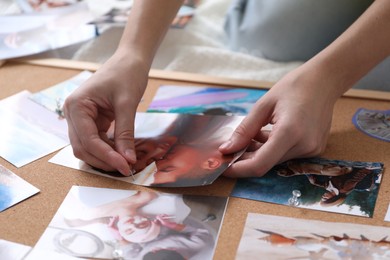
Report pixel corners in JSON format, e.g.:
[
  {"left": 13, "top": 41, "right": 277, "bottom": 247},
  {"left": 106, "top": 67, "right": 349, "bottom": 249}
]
[{"left": 35, "top": 186, "right": 227, "bottom": 260}]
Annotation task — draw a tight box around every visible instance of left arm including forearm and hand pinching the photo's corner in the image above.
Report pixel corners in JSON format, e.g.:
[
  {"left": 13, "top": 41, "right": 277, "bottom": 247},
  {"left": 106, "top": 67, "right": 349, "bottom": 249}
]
[{"left": 64, "top": 0, "right": 183, "bottom": 176}]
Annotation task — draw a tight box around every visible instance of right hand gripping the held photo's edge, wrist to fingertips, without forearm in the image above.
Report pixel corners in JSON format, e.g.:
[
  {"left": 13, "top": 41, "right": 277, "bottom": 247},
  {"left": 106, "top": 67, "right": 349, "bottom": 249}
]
[{"left": 220, "top": 69, "right": 337, "bottom": 177}]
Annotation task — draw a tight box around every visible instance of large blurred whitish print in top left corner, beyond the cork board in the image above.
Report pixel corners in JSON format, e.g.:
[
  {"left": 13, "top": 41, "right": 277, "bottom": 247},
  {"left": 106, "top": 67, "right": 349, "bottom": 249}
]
[{"left": 0, "top": 2, "right": 97, "bottom": 60}]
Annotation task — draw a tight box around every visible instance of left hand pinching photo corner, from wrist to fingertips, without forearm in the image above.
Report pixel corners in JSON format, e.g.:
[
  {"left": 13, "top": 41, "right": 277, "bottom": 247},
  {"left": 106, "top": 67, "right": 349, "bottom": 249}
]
[{"left": 64, "top": 54, "right": 149, "bottom": 176}]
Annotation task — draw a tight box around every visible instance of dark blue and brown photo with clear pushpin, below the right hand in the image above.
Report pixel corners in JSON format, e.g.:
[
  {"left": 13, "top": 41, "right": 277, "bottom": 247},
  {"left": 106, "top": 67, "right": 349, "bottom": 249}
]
[{"left": 231, "top": 158, "right": 383, "bottom": 217}]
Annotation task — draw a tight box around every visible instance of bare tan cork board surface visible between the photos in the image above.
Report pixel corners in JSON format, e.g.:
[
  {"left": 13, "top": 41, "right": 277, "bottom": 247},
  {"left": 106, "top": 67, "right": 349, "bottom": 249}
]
[{"left": 0, "top": 63, "right": 390, "bottom": 259}]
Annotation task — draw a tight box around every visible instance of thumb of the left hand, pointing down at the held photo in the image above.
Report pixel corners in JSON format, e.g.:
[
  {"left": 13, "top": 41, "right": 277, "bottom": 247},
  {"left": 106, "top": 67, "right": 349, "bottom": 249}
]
[{"left": 114, "top": 110, "right": 137, "bottom": 164}]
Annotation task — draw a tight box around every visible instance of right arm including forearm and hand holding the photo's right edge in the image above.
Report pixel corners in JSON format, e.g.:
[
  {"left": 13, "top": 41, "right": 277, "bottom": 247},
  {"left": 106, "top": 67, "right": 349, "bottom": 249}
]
[{"left": 220, "top": 0, "right": 390, "bottom": 177}]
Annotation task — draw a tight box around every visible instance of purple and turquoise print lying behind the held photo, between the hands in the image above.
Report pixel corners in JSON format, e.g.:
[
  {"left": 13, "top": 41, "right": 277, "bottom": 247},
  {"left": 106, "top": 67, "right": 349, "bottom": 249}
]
[{"left": 148, "top": 85, "right": 267, "bottom": 116}]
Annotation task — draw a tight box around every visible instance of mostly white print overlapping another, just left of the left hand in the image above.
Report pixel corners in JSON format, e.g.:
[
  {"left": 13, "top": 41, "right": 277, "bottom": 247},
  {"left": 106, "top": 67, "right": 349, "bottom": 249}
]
[{"left": 0, "top": 91, "right": 69, "bottom": 167}]
